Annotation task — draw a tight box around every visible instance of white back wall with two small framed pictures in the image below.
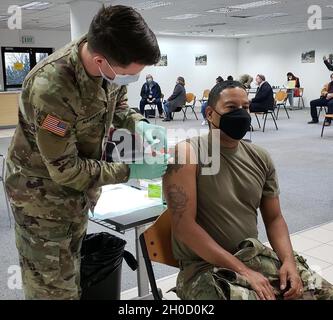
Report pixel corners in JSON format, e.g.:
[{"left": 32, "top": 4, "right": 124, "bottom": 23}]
[{"left": 128, "top": 37, "right": 238, "bottom": 107}]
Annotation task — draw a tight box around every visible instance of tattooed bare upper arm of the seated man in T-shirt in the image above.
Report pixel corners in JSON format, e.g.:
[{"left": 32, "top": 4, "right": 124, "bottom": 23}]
[{"left": 163, "top": 142, "right": 197, "bottom": 235}]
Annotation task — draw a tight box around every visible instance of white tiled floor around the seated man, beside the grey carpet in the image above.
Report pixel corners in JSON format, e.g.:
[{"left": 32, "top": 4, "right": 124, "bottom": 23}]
[{"left": 121, "top": 222, "right": 333, "bottom": 300}]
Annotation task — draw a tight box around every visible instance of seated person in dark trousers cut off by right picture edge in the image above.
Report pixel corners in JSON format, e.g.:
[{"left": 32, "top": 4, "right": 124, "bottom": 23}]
[{"left": 308, "top": 73, "right": 333, "bottom": 126}]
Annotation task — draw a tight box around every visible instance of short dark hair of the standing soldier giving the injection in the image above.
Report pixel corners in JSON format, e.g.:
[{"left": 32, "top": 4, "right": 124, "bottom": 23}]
[{"left": 87, "top": 5, "right": 161, "bottom": 66}]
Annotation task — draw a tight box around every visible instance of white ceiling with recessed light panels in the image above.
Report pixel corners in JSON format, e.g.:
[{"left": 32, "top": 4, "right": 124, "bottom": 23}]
[{"left": 0, "top": 0, "right": 333, "bottom": 37}]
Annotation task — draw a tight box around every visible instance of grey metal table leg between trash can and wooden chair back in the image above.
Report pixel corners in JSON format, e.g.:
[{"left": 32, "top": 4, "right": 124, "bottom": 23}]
[{"left": 135, "top": 226, "right": 149, "bottom": 297}]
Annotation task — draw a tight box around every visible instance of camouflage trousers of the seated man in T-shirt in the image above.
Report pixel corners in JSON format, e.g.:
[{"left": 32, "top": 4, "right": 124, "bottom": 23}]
[{"left": 177, "top": 239, "right": 333, "bottom": 300}]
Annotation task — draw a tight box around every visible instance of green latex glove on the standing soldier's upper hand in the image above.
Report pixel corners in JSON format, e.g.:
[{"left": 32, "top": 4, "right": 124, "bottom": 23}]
[{"left": 135, "top": 121, "right": 168, "bottom": 154}]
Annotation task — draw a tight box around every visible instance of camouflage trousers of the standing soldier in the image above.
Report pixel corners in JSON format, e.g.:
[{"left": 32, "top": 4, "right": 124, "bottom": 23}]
[{"left": 12, "top": 207, "right": 88, "bottom": 300}]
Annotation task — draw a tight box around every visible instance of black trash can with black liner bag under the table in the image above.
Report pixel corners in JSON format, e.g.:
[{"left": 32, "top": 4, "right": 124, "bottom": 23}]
[{"left": 81, "top": 232, "right": 138, "bottom": 300}]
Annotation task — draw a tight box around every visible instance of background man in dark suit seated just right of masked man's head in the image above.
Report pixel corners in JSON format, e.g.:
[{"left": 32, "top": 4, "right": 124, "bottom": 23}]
[{"left": 250, "top": 74, "right": 274, "bottom": 112}]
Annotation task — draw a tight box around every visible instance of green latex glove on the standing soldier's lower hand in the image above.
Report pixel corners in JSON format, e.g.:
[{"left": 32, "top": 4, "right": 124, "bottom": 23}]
[{"left": 128, "top": 155, "right": 169, "bottom": 179}]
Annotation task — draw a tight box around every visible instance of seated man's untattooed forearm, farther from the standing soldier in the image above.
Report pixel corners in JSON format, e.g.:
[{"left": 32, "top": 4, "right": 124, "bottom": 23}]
[{"left": 266, "top": 216, "right": 294, "bottom": 263}]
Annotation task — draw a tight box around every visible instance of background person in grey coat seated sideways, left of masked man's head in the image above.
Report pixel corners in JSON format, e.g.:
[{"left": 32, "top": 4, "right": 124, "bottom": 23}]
[{"left": 163, "top": 77, "right": 186, "bottom": 121}]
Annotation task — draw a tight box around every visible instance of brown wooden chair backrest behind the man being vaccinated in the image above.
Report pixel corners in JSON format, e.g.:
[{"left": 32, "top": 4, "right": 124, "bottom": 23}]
[{"left": 143, "top": 209, "right": 179, "bottom": 268}]
